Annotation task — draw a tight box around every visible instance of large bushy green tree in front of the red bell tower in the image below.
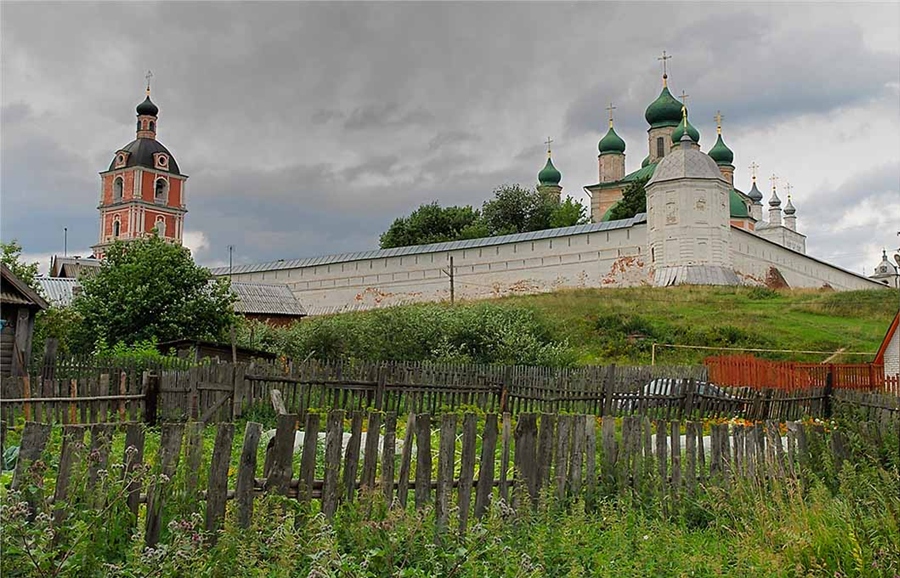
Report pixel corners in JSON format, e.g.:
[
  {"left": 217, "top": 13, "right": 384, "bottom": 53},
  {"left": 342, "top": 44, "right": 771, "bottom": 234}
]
[{"left": 72, "top": 235, "right": 236, "bottom": 348}]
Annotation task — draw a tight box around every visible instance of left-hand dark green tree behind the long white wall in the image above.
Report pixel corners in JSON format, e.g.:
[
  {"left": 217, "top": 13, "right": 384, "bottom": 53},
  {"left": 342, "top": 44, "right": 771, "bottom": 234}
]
[{"left": 380, "top": 202, "right": 487, "bottom": 249}]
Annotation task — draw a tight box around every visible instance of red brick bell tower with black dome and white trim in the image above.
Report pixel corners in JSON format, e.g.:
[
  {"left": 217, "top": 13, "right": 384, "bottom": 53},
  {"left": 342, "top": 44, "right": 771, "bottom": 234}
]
[{"left": 93, "top": 72, "right": 188, "bottom": 258}]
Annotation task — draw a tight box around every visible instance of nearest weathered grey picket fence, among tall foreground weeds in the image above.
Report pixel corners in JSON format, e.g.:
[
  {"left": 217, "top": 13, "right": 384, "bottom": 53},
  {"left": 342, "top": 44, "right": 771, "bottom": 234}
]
[{"left": 12, "top": 410, "right": 900, "bottom": 546}]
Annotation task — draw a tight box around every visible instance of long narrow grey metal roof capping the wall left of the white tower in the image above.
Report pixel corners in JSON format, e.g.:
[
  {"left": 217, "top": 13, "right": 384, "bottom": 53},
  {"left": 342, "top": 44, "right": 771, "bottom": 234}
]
[{"left": 212, "top": 213, "right": 647, "bottom": 276}]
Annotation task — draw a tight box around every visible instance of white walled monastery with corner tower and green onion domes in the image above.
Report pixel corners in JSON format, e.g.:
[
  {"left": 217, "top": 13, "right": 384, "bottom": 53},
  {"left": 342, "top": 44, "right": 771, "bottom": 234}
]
[{"left": 213, "top": 69, "right": 886, "bottom": 314}]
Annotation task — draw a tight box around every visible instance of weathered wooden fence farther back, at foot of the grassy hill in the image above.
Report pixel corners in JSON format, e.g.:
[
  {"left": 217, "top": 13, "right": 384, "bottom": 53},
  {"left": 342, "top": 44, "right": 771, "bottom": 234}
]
[{"left": 7, "top": 361, "right": 896, "bottom": 424}]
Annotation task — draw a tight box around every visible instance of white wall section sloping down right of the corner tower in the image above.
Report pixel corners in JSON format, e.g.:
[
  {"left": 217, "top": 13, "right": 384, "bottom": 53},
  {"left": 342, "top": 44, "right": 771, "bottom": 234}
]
[{"left": 730, "top": 227, "right": 880, "bottom": 291}]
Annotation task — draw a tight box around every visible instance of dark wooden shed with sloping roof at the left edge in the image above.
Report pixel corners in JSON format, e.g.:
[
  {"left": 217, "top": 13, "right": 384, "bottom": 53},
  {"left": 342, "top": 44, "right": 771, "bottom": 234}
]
[{"left": 0, "top": 264, "right": 49, "bottom": 376}]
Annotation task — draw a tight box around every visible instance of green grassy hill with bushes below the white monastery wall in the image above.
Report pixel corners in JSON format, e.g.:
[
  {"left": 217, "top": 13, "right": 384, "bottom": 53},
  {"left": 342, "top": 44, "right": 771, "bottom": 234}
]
[{"left": 242, "top": 287, "right": 900, "bottom": 365}]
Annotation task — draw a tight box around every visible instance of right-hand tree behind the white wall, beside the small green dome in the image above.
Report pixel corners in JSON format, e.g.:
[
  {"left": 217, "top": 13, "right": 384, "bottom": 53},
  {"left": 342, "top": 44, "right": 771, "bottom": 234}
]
[{"left": 481, "top": 185, "right": 587, "bottom": 236}]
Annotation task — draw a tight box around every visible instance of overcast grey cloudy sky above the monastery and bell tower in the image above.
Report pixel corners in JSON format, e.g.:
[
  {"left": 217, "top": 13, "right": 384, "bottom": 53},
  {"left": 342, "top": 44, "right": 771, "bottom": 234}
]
[{"left": 0, "top": 2, "right": 900, "bottom": 274}]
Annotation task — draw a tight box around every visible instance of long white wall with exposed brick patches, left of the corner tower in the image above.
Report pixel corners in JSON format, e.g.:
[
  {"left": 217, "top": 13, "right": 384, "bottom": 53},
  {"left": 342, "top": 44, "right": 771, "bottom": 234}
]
[{"left": 224, "top": 223, "right": 649, "bottom": 314}]
